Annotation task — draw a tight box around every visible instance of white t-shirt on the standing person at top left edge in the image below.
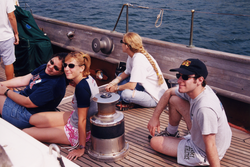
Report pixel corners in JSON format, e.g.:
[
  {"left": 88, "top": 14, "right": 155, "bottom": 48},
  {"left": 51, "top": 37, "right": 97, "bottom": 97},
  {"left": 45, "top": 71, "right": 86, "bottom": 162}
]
[{"left": 0, "top": 0, "right": 15, "bottom": 41}]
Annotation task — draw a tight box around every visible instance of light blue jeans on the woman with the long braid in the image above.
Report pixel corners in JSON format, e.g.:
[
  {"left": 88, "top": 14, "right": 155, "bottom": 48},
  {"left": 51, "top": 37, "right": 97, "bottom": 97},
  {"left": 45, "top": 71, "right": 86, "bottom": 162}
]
[{"left": 117, "top": 77, "right": 157, "bottom": 107}]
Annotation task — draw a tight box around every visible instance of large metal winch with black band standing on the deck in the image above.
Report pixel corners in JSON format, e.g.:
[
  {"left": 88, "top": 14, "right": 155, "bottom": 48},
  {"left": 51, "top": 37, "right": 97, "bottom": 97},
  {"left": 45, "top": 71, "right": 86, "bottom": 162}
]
[{"left": 88, "top": 92, "right": 129, "bottom": 162}]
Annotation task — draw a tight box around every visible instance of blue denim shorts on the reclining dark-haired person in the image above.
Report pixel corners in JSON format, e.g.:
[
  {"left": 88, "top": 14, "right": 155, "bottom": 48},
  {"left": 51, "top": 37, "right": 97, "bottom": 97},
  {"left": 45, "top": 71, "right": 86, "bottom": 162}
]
[{"left": 2, "top": 97, "right": 32, "bottom": 129}]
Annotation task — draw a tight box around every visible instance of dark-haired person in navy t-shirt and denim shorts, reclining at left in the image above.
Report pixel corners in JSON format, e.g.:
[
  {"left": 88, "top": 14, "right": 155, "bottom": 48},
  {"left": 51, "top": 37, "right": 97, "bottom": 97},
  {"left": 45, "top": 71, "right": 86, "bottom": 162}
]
[{"left": 0, "top": 53, "right": 67, "bottom": 129}]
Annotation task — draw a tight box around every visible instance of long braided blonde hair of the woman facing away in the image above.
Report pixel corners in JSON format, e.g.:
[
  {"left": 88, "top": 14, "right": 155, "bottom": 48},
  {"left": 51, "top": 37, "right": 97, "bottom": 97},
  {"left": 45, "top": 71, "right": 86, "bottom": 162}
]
[{"left": 123, "top": 32, "right": 164, "bottom": 85}]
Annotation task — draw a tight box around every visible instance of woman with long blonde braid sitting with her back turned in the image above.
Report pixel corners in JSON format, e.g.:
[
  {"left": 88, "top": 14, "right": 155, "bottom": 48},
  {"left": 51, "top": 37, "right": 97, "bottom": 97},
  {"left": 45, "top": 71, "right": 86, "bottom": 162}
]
[{"left": 105, "top": 32, "right": 168, "bottom": 107}]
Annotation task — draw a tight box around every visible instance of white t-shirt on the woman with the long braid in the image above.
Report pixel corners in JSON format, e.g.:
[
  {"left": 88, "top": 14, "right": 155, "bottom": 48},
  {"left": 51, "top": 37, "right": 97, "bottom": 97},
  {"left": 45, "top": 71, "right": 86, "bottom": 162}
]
[{"left": 124, "top": 53, "right": 168, "bottom": 103}]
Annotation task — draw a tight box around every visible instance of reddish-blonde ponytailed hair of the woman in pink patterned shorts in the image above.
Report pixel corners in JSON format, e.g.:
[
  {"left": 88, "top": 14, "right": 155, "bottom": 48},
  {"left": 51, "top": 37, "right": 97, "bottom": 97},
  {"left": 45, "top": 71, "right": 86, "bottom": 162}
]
[{"left": 65, "top": 52, "right": 91, "bottom": 77}]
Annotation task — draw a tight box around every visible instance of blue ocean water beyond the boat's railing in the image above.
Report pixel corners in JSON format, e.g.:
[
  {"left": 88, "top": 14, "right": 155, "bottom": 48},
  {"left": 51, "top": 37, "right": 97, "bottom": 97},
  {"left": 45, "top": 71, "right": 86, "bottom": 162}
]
[{"left": 19, "top": 0, "right": 250, "bottom": 56}]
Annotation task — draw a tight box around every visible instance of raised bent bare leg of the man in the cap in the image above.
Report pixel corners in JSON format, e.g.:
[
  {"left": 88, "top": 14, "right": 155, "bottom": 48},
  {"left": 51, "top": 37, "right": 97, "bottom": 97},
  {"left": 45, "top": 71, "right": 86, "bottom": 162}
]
[{"left": 169, "top": 96, "right": 192, "bottom": 130}]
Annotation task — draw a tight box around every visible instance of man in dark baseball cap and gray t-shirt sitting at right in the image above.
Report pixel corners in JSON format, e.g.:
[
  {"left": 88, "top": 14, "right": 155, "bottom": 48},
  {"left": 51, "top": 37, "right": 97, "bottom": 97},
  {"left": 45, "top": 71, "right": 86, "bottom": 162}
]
[{"left": 148, "top": 59, "right": 232, "bottom": 166}]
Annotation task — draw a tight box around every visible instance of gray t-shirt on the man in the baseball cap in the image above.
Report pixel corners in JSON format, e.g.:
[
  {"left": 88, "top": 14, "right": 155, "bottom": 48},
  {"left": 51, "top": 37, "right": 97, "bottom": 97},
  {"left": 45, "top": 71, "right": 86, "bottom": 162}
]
[{"left": 175, "top": 86, "right": 232, "bottom": 159}]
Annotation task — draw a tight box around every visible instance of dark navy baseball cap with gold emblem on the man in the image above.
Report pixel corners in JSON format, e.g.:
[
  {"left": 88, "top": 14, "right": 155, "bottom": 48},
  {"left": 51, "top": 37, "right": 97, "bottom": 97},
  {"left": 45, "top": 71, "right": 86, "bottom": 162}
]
[{"left": 170, "top": 59, "right": 208, "bottom": 79}]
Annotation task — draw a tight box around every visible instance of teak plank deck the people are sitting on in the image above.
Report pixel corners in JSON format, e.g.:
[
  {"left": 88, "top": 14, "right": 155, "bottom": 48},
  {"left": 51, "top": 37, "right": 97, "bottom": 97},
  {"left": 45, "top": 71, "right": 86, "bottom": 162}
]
[{"left": 0, "top": 63, "right": 250, "bottom": 167}]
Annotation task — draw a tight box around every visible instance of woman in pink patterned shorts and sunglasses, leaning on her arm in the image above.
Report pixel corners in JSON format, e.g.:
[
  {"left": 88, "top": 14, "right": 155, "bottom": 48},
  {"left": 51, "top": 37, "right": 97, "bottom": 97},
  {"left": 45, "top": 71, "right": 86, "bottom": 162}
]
[{"left": 24, "top": 52, "right": 99, "bottom": 160}]
